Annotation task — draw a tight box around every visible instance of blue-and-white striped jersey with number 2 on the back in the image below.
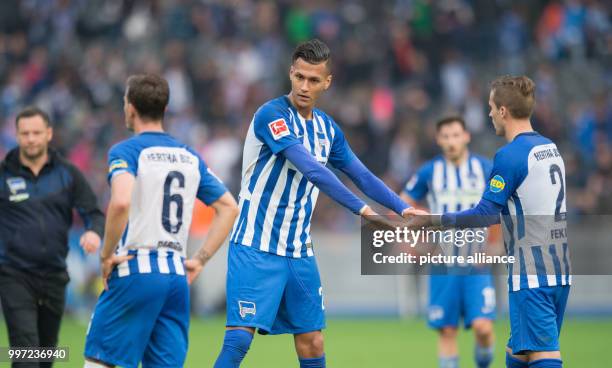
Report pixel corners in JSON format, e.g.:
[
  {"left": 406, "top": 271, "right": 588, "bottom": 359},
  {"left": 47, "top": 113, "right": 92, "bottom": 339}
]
[{"left": 483, "top": 132, "right": 572, "bottom": 291}]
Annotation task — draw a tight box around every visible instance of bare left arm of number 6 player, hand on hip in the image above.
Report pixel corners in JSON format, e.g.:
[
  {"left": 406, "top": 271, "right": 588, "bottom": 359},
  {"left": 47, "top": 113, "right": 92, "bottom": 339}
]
[{"left": 100, "top": 172, "right": 135, "bottom": 290}]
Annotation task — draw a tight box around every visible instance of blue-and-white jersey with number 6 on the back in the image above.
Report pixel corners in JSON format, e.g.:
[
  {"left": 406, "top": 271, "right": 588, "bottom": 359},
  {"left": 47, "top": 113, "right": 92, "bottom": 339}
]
[{"left": 108, "top": 132, "right": 227, "bottom": 276}]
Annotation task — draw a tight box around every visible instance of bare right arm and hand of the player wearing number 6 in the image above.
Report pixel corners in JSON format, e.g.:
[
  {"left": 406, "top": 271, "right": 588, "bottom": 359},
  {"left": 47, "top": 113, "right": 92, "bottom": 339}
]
[{"left": 185, "top": 192, "right": 238, "bottom": 284}]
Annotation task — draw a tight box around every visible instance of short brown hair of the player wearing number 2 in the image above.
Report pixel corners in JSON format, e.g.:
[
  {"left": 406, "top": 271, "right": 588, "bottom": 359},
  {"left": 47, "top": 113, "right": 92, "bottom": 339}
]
[{"left": 491, "top": 75, "right": 535, "bottom": 119}]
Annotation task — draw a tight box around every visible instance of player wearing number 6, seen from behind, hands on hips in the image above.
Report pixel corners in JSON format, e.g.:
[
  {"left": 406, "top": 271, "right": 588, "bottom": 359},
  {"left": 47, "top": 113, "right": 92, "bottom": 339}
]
[{"left": 85, "top": 75, "right": 238, "bottom": 368}]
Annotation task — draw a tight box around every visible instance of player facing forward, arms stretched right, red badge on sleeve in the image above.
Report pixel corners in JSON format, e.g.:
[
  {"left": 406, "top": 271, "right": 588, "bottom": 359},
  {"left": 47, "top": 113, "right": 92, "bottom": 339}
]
[{"left": 215, "top": 39, "right": 413, "bottom": 368}]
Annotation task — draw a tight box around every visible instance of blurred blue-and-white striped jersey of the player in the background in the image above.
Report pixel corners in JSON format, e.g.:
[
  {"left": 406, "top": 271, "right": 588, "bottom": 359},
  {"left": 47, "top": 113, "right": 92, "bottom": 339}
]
[{"left": 404, "top": 153, "right": 492, "bottom": 257}]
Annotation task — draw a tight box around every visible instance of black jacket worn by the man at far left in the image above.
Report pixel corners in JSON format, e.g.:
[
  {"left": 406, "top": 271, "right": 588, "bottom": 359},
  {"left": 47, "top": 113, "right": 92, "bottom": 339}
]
[{"left": 0, "top": 148, "right": 104, "bottom": 275}]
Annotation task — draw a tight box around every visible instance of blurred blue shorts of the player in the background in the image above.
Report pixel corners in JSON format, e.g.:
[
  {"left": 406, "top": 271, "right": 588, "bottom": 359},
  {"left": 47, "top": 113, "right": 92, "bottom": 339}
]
[{"left": 428, "top": 273, "right": 495, "bottom": 329}]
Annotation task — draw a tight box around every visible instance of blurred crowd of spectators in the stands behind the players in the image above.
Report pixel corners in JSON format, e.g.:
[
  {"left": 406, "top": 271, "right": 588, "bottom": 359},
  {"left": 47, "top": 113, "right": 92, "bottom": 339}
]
[{"left": 0, "top": 0, "right": 612, "bottom": 310}]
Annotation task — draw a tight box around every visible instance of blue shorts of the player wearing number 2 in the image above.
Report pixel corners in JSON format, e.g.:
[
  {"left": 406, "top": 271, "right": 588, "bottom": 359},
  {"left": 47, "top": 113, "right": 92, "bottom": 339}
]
[{"left": 508, "top": 285, "right": 570, "bottom": 355}]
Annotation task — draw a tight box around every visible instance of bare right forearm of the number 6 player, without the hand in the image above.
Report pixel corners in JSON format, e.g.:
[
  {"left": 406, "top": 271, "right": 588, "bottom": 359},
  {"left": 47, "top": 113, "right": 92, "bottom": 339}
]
[{"left": 194, "top": 193, "right": 238, "bottom": 265}]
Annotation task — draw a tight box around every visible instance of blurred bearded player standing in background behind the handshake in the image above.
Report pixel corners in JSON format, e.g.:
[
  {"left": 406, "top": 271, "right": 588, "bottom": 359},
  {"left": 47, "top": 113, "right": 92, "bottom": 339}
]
[{"left": 400, "top": 116, "right": 495, "bottom": 368}]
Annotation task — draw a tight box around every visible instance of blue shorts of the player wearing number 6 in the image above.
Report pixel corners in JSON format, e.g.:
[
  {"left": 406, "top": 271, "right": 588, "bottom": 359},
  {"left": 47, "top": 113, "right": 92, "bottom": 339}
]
[{"left": 85, "top": 273, "right": 189, "bottom": 368}]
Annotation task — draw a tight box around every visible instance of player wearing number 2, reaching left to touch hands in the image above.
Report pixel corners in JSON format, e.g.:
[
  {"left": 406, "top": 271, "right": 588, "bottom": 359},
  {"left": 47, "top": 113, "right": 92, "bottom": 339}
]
[{"left": 409, "top": 76, "right": 571, "bottom": 368}]
